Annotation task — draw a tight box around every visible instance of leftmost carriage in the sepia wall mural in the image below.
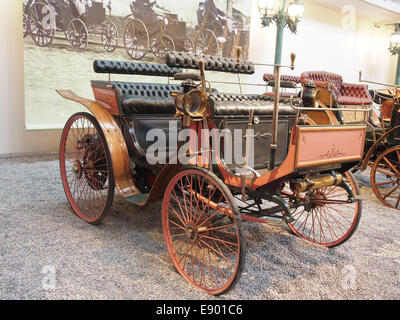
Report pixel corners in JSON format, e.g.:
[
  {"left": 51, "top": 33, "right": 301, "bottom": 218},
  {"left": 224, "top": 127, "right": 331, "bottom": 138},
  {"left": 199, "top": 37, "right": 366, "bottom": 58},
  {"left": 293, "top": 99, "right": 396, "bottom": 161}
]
[{"left": 23, "top": 0, "right": 118, "bottom": 52}]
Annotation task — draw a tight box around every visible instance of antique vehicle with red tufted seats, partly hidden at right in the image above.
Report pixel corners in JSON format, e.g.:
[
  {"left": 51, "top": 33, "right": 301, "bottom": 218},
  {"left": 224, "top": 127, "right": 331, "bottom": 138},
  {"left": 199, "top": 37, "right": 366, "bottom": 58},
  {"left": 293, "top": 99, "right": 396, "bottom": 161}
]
[{"left": 301, "top": 72, "right": 400, "bottom": 209}]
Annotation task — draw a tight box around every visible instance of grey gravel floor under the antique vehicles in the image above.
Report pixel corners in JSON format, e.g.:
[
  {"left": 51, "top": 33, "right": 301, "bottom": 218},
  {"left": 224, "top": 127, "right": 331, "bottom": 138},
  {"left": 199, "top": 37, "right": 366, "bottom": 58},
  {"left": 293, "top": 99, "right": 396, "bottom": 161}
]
[{"left": 0, "top": 156, "right": 400, "bottom": 299}]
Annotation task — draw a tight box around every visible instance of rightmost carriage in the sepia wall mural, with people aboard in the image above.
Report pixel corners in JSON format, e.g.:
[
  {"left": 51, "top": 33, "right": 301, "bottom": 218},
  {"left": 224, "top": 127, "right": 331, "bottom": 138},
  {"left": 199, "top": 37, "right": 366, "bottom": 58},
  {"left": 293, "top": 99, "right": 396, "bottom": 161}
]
[{"left": 195, "top": 0, "right": 250, "bottom": 58}]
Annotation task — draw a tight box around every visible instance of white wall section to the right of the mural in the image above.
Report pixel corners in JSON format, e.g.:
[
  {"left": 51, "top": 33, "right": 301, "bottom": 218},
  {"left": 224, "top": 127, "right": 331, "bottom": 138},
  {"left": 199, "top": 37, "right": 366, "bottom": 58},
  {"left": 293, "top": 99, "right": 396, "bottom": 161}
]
[{"left": 250, "top": 0, "right": 400, "bottom": 88}]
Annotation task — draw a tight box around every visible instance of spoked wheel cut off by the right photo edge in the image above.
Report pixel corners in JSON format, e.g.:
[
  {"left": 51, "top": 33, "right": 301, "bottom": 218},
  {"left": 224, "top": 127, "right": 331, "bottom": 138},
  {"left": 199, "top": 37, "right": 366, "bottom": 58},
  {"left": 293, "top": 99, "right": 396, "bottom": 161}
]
[{"left": 371, "top": 146, "right": 400, "bottom": 209}]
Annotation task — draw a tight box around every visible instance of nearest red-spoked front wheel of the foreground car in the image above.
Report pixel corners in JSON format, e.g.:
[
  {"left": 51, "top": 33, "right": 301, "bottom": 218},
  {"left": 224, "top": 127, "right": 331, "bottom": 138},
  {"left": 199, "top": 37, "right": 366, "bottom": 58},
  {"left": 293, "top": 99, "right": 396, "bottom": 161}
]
[{"left": 162, "top": 167, "right": 246, "bottom": 295}]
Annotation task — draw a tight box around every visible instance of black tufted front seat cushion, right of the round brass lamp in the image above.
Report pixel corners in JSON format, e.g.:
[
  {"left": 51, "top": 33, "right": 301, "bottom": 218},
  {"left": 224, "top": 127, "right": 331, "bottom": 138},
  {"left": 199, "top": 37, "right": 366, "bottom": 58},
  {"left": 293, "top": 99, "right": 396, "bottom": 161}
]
[{"left": 210, "top": 93, "right": 296, "bottom": 117}]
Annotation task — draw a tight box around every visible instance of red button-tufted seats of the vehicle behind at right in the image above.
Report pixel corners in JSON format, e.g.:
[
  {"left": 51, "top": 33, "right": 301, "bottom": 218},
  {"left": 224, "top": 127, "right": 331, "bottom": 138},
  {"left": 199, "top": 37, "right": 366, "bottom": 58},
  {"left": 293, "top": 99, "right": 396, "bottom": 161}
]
[{"left": 301, "top": 71, "right": 372, "bottom": 105}]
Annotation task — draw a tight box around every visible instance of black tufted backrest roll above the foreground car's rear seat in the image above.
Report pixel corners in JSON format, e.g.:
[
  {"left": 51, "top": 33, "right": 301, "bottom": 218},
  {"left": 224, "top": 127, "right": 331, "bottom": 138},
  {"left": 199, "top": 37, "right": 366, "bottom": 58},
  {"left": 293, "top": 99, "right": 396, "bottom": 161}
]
[{"left": 93, "top": 60, "right": 182, "bottom": 77}]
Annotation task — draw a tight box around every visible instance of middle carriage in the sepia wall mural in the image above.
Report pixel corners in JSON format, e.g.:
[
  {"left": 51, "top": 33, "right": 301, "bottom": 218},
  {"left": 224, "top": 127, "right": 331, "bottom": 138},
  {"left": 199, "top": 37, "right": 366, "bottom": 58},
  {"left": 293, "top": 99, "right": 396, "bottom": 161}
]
[{"left": 124, "top": 0, "right": 194, "bottom": 60}]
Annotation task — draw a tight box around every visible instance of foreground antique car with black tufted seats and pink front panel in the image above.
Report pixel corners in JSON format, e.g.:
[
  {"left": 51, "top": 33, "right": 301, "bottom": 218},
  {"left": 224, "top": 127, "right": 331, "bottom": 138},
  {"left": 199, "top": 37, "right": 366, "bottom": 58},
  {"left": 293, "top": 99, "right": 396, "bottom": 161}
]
[{"left": 58, "top": 50, "right": 366, "bottom": 295}]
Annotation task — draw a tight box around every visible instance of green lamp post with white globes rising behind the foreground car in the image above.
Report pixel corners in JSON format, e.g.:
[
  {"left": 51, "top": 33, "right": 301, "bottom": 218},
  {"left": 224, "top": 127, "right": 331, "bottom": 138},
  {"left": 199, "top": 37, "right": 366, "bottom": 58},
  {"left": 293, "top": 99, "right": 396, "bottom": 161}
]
[{"left": 258, "top": 0, "right": 304, "bottom": 64}]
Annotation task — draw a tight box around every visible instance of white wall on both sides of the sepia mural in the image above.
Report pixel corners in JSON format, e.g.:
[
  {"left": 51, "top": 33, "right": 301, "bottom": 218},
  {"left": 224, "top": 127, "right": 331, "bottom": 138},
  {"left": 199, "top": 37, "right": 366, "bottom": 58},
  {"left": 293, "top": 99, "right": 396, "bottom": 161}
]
[{"left": 0, "top": 0, "right": 396, "bottom": 154}]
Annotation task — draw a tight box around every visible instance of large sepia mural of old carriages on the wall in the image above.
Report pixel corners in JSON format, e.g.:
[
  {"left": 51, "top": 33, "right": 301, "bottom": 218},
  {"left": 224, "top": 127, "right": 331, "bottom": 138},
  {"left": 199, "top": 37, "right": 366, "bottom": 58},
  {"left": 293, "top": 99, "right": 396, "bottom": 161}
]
[{"left": 22, "top": 0, "right": 251, "bottom": 129}]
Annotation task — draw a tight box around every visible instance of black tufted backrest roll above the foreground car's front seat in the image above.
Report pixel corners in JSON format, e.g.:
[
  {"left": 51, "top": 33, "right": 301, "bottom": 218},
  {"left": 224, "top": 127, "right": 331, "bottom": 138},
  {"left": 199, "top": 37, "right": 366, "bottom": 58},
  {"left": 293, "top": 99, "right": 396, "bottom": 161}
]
[{"left": 165, "top": 51, "right": 254, "bottom": 74}]
